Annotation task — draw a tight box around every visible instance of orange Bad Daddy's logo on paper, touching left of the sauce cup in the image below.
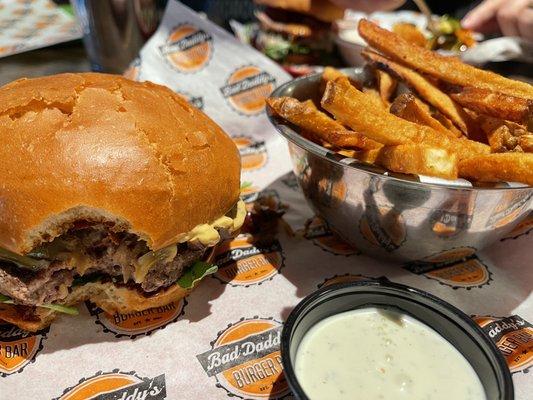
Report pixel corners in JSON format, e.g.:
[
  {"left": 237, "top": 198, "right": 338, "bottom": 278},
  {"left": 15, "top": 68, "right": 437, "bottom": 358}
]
[{"left": 196, "top": 317, "right": 289, "bottom": 399}]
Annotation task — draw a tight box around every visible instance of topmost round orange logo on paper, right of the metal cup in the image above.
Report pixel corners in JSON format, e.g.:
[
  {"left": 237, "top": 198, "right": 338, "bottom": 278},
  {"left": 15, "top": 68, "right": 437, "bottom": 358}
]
[{"left": 159, "top": 24, "right": 213, "bottom": 72}]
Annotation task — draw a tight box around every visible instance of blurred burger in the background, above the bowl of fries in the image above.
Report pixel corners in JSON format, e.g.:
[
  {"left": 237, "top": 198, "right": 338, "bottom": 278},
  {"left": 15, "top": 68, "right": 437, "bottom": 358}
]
[{"left": 254, "top": 0, "right": 344, "bottom": 65}]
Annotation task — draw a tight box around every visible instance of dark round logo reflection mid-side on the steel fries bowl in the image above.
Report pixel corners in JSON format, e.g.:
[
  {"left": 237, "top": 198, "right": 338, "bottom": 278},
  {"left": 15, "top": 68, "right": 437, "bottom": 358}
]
[{"left": 359, "top": 205, "right": 407, "bottom": 252}]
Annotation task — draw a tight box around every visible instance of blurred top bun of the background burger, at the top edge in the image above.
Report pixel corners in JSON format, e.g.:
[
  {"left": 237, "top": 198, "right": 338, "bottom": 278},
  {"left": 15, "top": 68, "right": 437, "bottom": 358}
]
[{"left": 254, "top": 0, "right": 344, "bottom": 22}]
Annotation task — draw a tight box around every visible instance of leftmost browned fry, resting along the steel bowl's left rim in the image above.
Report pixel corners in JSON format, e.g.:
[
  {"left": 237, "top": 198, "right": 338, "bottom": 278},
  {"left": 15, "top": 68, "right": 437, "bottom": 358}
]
[{"left": 267, "top": 96, "right": 381, "bottom": 149}]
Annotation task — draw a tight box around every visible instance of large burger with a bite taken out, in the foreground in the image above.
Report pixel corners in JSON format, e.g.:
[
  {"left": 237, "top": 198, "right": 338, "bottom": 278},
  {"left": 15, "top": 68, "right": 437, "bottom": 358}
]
[{"left": 0, "top": 73, "right": 246, "bottom": 331}]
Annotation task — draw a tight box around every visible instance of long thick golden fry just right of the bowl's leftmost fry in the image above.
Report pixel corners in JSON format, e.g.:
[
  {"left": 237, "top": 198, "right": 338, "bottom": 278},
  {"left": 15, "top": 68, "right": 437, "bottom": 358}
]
[{"left": 321, "top": 78, "right": 490, "bottom": 159}]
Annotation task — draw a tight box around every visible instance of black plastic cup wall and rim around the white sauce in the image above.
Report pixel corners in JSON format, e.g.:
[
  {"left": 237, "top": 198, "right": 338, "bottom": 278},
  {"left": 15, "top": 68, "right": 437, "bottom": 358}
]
[{"left": 281, "top": 280, "right": 514, "bottom": 400}]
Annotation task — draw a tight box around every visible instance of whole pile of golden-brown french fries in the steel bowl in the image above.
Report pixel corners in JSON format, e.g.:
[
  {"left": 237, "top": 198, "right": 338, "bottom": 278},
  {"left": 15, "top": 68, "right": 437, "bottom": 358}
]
[{"left": 267, "top": 20, "right": 533, "bottom": 186}]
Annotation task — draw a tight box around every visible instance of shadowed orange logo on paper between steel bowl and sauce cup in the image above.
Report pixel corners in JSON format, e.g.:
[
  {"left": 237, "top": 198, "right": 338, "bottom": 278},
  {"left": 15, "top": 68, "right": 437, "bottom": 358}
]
[{"left": 405, "top": 247, "right": 491, "bottom": 289}]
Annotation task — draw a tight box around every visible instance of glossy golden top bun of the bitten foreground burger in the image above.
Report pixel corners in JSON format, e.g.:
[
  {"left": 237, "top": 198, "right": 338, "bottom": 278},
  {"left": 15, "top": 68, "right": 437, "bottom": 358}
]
[{"left": 0, "top": 73, "right": 240, "bottom": 254}]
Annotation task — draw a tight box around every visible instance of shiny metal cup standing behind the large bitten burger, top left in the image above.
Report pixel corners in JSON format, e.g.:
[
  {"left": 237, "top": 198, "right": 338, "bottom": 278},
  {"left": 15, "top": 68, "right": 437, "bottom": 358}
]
[{"left": 71, "top": 0, "right": 166, "bottom": 73}]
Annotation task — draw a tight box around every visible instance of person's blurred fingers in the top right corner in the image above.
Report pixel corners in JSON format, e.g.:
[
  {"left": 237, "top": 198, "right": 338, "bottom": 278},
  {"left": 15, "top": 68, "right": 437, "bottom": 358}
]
[{"left": 461, "top": 0, "right": 533, "bottom": 41}]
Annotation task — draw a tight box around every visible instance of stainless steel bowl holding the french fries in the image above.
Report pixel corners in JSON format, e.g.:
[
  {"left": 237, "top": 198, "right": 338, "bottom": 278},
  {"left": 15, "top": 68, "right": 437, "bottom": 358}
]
[{"left": 268, "top": 69, "right": 533, "bottom": 262}]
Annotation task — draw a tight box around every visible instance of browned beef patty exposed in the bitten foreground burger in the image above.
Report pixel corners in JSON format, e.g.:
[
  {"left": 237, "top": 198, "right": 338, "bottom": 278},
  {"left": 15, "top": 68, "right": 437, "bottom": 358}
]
[{"left": 0, "top": 223, "right": 211, "bottom": 305}]
